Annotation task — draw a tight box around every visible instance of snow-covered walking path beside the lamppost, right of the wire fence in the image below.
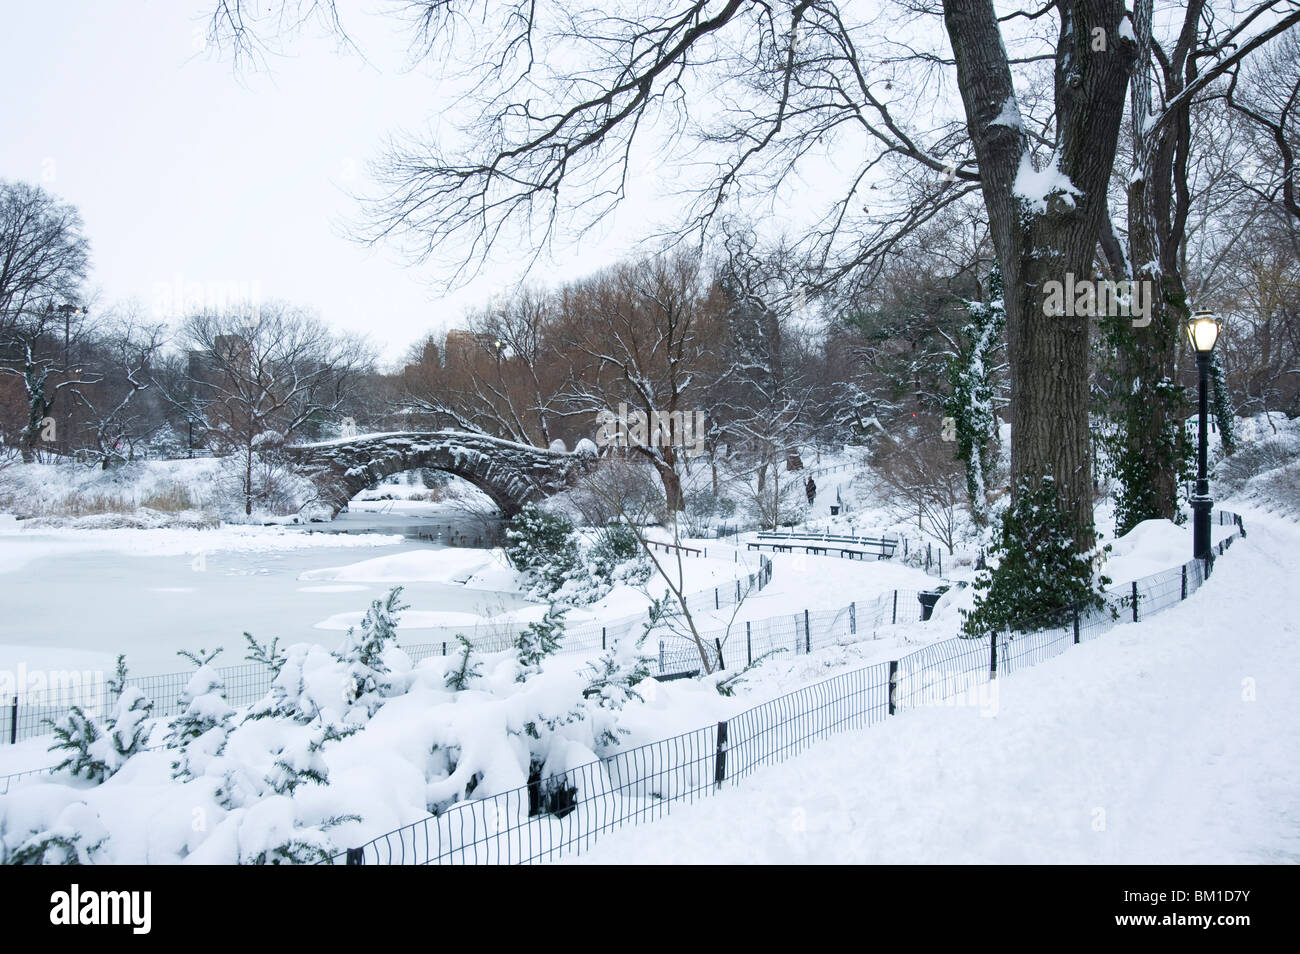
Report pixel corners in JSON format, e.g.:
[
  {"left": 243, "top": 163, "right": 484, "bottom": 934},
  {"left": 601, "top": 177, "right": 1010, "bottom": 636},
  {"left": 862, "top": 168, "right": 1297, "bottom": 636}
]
[{"left": 582, "top": 513, "right": 1300, "bottom": 864}]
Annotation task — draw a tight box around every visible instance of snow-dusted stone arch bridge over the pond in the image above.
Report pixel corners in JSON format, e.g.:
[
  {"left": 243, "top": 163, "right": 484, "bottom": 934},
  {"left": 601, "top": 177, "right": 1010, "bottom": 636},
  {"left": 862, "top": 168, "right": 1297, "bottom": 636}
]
[{"left": 285, "top": 430, "right": 595, "bottom": 516}]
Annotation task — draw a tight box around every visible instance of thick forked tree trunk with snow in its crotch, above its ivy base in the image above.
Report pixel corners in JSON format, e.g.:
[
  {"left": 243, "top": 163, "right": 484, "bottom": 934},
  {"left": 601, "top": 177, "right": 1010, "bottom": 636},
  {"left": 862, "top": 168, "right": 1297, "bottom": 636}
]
[{"left": 944, "top": 0, "right": 1135, "bottom": 550}]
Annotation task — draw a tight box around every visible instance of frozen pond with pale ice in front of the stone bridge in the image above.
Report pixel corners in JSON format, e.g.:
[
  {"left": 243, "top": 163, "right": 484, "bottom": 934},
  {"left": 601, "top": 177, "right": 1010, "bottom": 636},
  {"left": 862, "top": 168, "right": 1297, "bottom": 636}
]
[{"left": 0, "top": 512, "right": 529, "bottom": 675}]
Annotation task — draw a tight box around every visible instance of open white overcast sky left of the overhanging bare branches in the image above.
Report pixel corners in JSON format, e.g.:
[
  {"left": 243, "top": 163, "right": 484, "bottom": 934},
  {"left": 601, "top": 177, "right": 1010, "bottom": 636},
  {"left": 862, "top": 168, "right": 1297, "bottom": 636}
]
[{"left": 0, "top": 0, "right": 665, "bottom": 359}]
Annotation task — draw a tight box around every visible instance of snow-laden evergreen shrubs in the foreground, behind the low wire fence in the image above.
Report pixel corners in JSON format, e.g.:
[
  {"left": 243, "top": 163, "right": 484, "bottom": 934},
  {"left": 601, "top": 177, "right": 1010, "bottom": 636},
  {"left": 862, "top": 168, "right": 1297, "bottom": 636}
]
[{"left": 0, "top": 589, "right": 647, "bottom": 864}]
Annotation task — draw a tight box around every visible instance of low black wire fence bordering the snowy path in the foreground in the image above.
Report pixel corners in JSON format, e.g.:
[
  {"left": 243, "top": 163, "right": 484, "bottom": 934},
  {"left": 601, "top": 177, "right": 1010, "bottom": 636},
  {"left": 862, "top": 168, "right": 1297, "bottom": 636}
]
[{"left": 319, "top": 513, "right": 1245, "bottom": 864}]
